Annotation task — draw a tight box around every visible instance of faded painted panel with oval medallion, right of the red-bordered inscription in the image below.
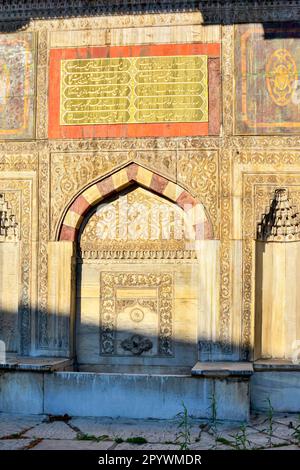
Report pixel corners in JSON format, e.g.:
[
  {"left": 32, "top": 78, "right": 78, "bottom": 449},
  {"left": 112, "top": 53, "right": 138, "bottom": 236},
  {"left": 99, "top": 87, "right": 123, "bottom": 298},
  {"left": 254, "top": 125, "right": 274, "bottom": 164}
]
[{"left": 235, "top": 23, "right": 300, "bottom": 134}]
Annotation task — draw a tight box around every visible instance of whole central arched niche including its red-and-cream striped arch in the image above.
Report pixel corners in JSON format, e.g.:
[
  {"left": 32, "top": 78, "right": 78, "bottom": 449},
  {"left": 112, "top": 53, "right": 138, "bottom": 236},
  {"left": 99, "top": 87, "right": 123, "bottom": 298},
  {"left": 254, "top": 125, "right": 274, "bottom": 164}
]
[{"left": 49, "top": 163, "right": 212, "bottom": 372}]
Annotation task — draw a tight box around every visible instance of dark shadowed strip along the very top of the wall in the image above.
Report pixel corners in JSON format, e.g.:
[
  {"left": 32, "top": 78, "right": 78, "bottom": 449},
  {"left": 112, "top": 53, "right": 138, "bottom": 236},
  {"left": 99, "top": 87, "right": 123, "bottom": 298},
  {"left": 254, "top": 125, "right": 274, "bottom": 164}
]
[{"left": 0, "top": 0, "right": 299, "bottom": 39}]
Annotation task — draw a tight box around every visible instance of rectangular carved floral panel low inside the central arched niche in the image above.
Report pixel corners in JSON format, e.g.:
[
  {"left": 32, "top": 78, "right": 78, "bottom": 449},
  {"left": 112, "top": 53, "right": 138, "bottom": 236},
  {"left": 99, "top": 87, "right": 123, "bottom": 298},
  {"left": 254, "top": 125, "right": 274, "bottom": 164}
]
[{"left": 100, "top": 272, "right": 173, "bottom": 356}]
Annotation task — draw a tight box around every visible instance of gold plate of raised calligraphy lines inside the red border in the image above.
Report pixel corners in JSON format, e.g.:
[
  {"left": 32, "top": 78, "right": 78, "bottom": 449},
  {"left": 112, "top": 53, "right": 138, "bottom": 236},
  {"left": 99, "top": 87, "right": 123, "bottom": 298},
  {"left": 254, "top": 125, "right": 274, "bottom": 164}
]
[{"left": 60, "top": 55, "right": 208, "bottom": 125}]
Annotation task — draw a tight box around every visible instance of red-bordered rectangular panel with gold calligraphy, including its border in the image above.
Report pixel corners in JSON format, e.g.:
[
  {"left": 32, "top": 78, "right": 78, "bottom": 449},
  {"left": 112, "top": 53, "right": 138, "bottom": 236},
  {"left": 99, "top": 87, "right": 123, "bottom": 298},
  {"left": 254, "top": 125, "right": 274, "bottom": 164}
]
[{"left": 49, "top": 43, "right": 220, "bottom": 138}]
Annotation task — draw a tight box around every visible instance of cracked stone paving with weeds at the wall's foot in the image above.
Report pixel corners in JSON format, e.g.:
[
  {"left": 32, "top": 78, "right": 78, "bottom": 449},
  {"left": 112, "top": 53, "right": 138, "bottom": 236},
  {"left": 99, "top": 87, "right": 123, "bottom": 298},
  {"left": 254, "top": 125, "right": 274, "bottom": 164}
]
[{"left": 0, "top": 413, "right": 300, "bottom": 450}]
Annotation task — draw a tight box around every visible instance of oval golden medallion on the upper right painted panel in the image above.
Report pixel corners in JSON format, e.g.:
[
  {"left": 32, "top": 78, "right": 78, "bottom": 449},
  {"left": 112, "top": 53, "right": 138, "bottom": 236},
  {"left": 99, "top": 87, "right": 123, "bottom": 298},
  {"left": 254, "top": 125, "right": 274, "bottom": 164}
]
[{"left": 266, "top": 49, "right": 298, "bottom": 106}]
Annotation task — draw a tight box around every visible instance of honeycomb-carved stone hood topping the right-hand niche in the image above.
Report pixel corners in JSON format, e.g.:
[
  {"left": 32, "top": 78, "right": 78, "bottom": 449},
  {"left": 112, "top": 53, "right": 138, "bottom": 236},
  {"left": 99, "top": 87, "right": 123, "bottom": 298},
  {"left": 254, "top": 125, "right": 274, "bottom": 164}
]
[{"left": 257, "top": 188, "right": 300, "bottom": 242}]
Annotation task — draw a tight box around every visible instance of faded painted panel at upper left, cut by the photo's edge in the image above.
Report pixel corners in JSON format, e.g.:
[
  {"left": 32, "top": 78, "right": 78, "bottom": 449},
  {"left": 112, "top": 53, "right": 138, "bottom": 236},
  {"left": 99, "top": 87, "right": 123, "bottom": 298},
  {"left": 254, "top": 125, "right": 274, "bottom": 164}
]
[{"left": 0, "top": 33, "right": 35, "bottom": 139}]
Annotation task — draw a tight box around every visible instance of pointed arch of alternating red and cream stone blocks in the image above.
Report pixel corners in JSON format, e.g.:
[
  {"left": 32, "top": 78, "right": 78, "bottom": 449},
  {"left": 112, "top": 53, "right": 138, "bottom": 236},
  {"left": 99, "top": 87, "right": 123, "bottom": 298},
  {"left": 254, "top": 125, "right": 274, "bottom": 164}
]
[{"left": 58, "top": 163, "right": 213, "bottom": 241}]
